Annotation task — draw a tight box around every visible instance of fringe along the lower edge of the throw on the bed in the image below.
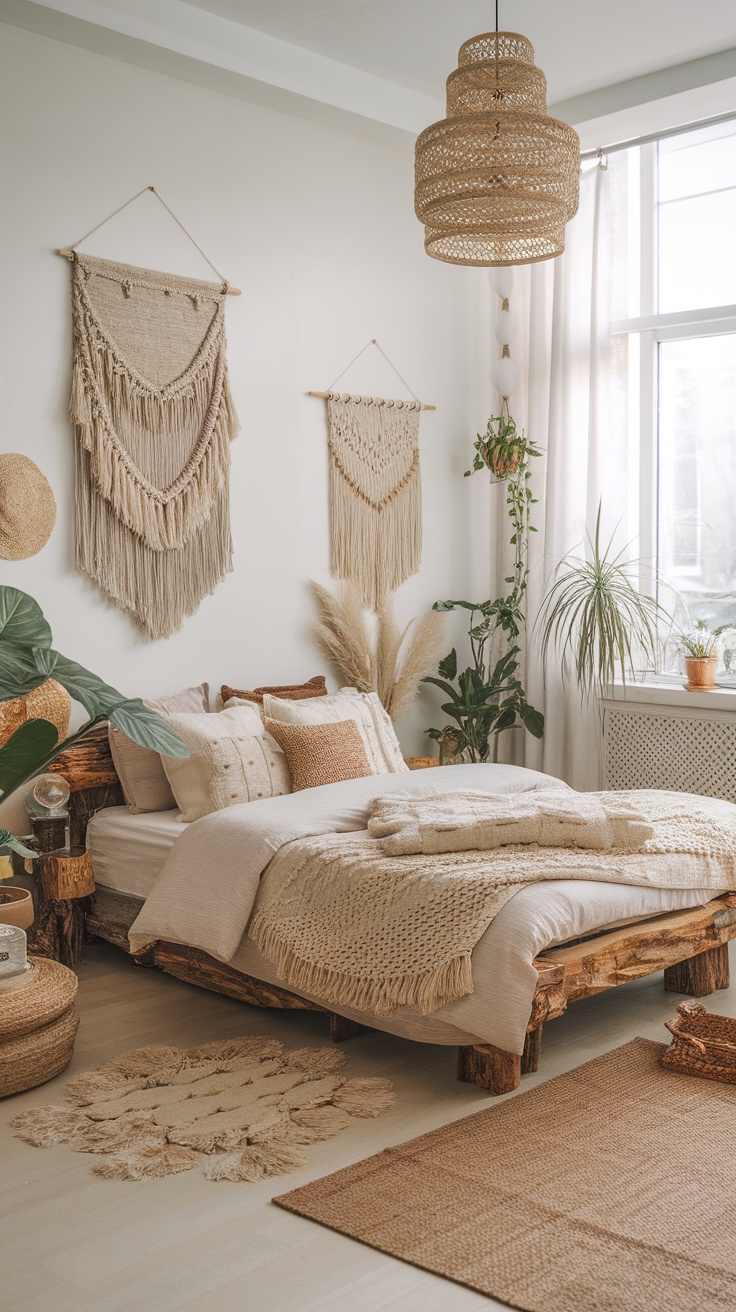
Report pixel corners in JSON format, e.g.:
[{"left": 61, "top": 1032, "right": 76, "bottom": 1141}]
[{"left": 248, "top": 912, "right": 474, "bottom": 1017}]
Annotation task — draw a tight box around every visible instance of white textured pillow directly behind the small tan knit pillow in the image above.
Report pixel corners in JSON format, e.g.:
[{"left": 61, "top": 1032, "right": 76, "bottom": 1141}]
[{"left": 264, "top": 687, "right": 408, "bottom": 774}]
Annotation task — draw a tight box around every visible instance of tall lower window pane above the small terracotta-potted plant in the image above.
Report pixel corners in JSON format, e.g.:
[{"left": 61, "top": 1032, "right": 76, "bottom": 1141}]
[{"left": 657, "top": 333, "right": 736, "bottom": 625}]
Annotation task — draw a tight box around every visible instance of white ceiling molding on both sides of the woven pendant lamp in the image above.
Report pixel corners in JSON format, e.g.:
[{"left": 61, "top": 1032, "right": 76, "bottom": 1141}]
[{"left": 0, "top": 0, "right": 736, "bottom": 151}]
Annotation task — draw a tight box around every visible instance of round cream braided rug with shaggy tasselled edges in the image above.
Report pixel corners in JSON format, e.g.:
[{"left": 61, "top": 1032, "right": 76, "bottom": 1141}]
[{"left": 13, "top": 1035, "right": 394, "bottom": 1179}]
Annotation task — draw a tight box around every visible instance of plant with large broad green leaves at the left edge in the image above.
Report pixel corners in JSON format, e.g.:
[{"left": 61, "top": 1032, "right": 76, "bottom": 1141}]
[{"left": 0, "top": 585, "right": 189, "bottom": 855}]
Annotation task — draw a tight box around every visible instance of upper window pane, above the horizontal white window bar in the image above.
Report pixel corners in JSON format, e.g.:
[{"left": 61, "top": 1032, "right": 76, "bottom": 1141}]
[{"left": 657, "top": 123, "right": 736, "bottom": 314}]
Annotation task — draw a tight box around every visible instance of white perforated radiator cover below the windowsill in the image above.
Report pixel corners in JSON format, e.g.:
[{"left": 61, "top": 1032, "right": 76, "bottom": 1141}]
[{"left": 602, "top": 686, "right": 736, "bottom": 802}]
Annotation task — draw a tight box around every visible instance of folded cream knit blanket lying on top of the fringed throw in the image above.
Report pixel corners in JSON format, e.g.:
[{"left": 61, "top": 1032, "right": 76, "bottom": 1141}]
[{"left": 369, "top": 789, "right": 655, "bottom": 857}]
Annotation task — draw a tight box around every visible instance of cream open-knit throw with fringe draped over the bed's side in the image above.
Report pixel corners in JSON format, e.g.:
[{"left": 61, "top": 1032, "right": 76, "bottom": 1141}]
[{"left": 249, "top": 791, "right": 736, "bottom": 1015}]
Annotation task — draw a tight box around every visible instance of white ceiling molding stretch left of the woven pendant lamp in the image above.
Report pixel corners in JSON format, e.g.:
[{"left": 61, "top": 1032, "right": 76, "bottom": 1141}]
[{"left": 0, "top": 0, "right": 443, "bottom": 148}]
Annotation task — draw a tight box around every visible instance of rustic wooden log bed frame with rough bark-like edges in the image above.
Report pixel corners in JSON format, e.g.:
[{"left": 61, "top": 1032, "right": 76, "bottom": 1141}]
[{"left": 50, "top": 726, "right": 736, "bottom": 1094}]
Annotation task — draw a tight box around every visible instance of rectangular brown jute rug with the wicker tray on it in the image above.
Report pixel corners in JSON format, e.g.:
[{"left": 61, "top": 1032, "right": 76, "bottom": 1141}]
[{"left": 274, "top": 1039, "right": 736, "bottom": 1312}]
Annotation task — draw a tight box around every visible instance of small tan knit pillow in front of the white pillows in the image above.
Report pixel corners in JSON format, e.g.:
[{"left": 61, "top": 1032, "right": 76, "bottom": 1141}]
[{"left": 265, "top": 719, "right": 373, "bottom": 792}]
